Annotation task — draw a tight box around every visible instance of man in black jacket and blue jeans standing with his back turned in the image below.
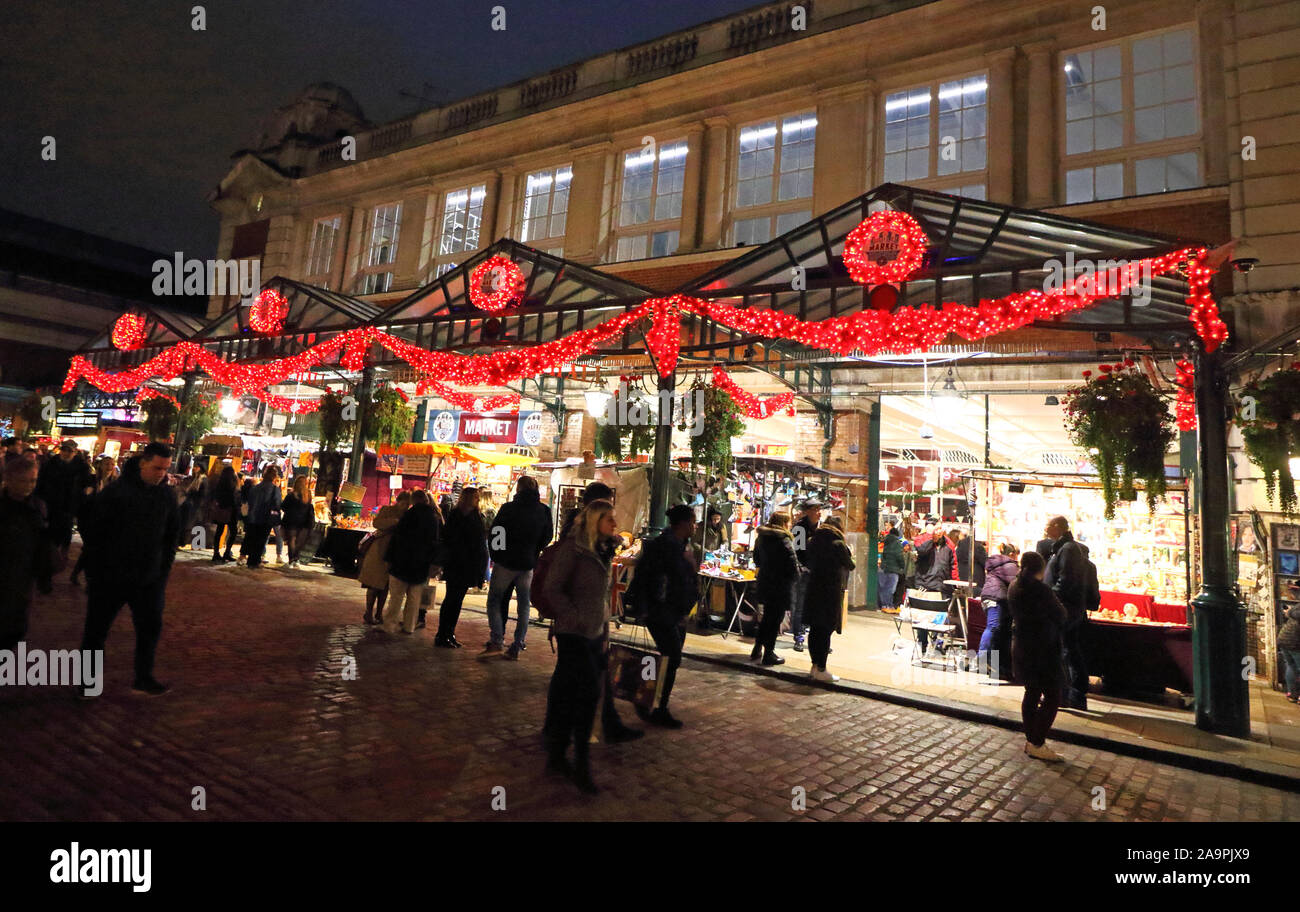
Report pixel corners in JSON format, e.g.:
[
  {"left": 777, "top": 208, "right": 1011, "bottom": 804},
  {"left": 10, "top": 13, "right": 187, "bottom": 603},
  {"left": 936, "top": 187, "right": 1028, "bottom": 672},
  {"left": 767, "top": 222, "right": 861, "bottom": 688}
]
[{"left": 488, "top": 475, "right": 555, "bottom": 661}]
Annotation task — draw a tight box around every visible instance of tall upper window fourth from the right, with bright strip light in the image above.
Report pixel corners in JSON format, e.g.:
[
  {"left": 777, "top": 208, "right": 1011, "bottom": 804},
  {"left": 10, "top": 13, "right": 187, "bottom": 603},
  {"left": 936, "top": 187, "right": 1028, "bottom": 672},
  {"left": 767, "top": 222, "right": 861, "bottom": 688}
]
[{"left": 614, "top": 139, "right": 686, "bottom": 260}]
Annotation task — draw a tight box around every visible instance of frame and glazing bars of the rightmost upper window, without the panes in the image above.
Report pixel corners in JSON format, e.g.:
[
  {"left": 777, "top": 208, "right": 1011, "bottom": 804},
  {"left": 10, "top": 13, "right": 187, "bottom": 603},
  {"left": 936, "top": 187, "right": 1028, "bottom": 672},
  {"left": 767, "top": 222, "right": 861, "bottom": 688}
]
[{"left": 1053, "top": 19, "right": 1205, "bottom": 205}]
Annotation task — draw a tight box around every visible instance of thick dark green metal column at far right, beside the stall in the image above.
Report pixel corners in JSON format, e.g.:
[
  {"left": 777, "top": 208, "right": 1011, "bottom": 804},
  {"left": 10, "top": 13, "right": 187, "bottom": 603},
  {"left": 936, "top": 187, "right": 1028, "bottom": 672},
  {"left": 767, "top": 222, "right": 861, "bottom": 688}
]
[{"left": 1191, "top": 349, "right": 1251, "bottom": 738}]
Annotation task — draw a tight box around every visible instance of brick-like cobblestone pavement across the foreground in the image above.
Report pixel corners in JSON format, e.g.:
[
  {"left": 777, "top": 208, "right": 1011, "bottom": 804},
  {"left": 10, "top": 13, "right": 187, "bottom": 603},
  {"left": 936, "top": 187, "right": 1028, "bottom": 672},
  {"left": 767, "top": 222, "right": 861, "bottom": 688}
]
[{"left": 0, "top": 556, "right": 1300, "bottom": 821}]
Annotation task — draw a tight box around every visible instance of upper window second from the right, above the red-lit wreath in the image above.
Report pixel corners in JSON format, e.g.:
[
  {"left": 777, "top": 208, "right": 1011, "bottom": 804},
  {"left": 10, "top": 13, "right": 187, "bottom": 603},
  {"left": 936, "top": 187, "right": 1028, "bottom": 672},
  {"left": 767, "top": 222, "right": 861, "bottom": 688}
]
[{"left": 884, "top": 74, "right": 988, "bottom": 192}]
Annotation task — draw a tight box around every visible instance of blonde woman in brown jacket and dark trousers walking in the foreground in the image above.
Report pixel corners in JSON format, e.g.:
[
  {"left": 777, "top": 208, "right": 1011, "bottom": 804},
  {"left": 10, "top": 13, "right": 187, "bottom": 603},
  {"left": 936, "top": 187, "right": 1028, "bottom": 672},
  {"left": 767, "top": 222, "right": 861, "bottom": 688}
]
[{"left": 543, "top": 500, "right": 618, "bottom": 795}]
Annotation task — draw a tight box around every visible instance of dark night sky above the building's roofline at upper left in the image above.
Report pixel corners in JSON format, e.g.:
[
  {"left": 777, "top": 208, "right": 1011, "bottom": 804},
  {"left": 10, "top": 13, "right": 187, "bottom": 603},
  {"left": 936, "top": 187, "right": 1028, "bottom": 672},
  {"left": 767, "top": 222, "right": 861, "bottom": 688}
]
[{"left": 0, "top": 0, "right": 755, "bottom": 259}]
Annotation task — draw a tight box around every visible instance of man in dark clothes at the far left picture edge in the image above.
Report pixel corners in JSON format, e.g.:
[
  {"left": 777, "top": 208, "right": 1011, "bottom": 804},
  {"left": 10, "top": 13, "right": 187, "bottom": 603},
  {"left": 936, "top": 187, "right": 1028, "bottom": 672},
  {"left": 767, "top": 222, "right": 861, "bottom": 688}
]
[{"left": 0, "top": 457, "right": 53, "bottom": 650}]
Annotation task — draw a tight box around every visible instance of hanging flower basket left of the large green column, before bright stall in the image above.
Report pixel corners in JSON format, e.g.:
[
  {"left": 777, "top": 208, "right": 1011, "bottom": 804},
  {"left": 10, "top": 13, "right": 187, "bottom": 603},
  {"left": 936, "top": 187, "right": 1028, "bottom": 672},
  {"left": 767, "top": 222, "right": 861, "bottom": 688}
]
[{"left": 1065, "top": 360, "right": 1175, "bottom": 520}]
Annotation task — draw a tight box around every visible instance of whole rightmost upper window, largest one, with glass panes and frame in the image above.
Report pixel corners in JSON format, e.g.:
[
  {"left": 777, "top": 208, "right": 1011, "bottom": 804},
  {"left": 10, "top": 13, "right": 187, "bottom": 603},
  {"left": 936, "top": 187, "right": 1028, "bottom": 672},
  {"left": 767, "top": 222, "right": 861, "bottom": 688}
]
[{"left": 1061, "top": 26, "right": 1201, "bottom": 203}]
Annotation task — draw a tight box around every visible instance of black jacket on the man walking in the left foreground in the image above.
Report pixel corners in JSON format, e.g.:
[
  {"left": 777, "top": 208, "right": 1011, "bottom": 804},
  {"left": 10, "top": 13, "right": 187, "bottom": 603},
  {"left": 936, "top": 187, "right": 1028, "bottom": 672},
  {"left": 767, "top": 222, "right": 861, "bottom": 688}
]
[{"left": 82, "top": 465, "right": 181, "bottom": 587}]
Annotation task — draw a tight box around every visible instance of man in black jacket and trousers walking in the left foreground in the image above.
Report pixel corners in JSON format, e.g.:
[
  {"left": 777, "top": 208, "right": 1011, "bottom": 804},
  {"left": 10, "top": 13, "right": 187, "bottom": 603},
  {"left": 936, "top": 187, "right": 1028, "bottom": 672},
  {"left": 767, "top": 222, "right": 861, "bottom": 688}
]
[{"left": 82, "top": 443, "right": 181, "bottom": 696}]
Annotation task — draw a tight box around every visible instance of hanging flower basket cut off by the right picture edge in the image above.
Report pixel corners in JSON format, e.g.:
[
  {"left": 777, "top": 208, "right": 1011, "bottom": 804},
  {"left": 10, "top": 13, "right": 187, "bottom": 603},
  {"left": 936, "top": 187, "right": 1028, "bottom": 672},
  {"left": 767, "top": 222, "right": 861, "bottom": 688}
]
[{"left": 1236, "top": 361, "right": 1300, "bottom": 513}]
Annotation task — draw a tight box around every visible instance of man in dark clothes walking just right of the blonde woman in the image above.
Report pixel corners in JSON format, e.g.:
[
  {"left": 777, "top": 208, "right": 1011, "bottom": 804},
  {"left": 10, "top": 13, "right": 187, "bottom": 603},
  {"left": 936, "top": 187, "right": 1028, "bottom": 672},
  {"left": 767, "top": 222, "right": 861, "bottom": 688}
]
[{"left": 633, "top": 504, "right": 699, "bottom": 729}]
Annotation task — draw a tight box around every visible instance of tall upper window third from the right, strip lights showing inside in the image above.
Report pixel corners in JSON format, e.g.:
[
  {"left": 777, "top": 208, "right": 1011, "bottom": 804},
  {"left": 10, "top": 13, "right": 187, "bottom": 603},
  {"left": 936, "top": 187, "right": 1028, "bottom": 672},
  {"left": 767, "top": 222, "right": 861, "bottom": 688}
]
[{"left": 732, "top": 112, "right": 816, "bottom": 244}]
